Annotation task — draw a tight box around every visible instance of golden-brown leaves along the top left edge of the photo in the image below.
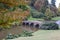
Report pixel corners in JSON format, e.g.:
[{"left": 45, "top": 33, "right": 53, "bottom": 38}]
[{"left": 0, "top": 0, "right": 26, "bottom": 7}]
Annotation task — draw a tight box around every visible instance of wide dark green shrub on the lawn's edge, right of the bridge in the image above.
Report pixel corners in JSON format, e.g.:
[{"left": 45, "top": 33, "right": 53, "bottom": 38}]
[{"left": 41, "top": 23, "right": 59, "bottom": 30}]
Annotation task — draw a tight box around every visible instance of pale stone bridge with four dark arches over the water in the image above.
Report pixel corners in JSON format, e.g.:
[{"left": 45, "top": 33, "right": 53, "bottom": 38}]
[{"left": 22, "top": 21, "right": 43, "bottom": 28}]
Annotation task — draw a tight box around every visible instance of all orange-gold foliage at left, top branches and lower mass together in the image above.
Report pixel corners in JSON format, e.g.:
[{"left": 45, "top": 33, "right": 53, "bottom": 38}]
[{"left": 0, "top": 0, "right": 30, "bottom": 28}]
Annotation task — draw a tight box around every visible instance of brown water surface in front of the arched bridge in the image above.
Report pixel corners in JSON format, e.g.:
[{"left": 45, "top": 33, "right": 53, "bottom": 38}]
[{"left": 0, "top": 26, "right": 38, "bottom": 40}]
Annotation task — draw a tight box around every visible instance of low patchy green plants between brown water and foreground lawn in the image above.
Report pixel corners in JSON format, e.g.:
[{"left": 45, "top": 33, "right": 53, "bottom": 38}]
[{"left": 6, "top": 31, "right": 32, "bottom": 39}]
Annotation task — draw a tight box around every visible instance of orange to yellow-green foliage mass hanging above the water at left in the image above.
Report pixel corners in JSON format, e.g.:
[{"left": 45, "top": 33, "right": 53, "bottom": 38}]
[{"left": 0, "top": 9, "right": 29, "bottom": 26}]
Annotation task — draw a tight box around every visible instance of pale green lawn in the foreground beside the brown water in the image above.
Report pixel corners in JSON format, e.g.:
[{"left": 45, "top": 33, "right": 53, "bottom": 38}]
[{"left": 8, "top": 30, "right": 60, "bottom": 40}]
